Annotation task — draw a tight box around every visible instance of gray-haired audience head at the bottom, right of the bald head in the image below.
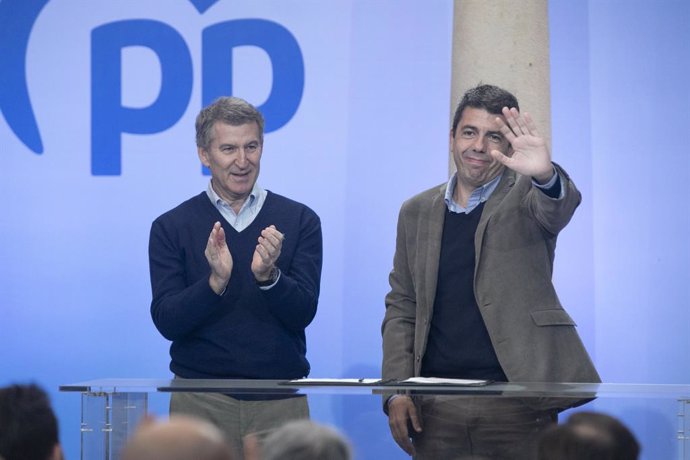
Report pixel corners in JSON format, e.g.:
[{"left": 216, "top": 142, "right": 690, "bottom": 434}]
[{"left": 253, "top": 419, "right": 352, "bottom": 460}]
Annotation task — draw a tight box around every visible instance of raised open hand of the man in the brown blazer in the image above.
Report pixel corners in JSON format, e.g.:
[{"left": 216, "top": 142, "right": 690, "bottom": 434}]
[{"left": 491, "top": 107, "right": 553, "bottom": 184}]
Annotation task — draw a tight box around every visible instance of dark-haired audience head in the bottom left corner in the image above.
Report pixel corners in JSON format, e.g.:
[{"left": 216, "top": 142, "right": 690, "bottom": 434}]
[{"left": 0, "top": 384, "right": 62, "bottom": 460}]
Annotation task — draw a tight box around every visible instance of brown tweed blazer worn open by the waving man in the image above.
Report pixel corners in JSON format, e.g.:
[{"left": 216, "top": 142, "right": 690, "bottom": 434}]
[{"left": 382, "top": 165, "right": 600, "bottom": 392}]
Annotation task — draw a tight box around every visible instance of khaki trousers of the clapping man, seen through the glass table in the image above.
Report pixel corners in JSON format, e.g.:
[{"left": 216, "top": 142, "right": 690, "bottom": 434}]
[{"left": 170, "top": 392, "right": 309, "bottom": 458}]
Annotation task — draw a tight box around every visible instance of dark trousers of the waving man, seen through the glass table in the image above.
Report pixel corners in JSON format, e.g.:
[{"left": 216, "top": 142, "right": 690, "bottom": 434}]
[{"left": 413, "top": 396, "right": 558, "bottom": 460}]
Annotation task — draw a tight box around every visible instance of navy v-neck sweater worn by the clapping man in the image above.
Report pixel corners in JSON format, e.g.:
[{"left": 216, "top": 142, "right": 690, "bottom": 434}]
[{"left": 149, "top": 192, "right": 322, "bottom": 379}]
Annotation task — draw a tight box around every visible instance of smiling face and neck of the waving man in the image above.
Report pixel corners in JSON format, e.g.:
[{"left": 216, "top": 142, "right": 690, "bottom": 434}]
[{"left": 450, "top": 107, "right": 511, "bottom": 198}]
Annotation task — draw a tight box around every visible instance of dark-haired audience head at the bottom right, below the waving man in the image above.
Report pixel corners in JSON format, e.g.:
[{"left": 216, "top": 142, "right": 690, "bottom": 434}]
[{"left": 539, "top": 412, "right": 640, "bottom": 460}]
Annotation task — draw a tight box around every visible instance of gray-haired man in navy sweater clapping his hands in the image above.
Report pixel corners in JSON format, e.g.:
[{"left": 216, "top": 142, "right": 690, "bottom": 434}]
[{"left": 149, "top": 97, "right": 322, "bottom": 449}]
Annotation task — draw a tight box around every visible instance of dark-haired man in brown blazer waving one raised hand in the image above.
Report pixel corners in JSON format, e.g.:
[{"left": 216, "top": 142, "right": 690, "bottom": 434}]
[{"left": 382, "top": 85, "right": 600, "bottom": 459}]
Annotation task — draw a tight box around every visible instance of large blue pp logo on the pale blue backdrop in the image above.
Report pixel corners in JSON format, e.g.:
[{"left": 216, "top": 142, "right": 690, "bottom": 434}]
[{"left": 0, "top": 0, "right": 304, "bottom": 176}]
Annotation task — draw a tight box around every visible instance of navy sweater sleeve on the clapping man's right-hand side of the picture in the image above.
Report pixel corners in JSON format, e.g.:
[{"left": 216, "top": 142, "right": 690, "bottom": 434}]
[{"left": 262, "top": 208, "right": 323, "bottom": 332}]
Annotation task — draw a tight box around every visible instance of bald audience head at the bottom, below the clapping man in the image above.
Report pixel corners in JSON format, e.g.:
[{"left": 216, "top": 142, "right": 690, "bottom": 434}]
[{"left": 122, "top": 415, "right": 234, "bottom": 460}]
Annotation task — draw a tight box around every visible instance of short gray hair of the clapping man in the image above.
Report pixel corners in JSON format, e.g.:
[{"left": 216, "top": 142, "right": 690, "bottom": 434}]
[{"left": 196, "top": 97, "right": 264, "bottom": 150}]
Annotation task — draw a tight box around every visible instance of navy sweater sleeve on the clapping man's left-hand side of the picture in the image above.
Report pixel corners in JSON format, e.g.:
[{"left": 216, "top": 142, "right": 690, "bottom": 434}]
[{"left": 149, "top": 218, "right": 230, "bottom": 340}]
